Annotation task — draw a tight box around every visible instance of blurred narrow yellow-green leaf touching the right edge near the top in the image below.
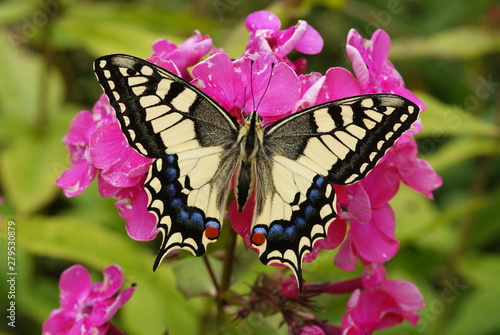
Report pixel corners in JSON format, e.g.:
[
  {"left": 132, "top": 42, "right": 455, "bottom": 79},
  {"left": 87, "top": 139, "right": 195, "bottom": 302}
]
[{"left": 390, "top": 26, "right": 500, "bottom": 60}]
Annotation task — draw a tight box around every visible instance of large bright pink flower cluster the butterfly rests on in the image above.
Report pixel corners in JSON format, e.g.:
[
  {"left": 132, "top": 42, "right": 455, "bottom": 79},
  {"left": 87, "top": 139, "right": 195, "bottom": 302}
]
[{"left": 57, "top": 11, "right": 441, "bottom": 334}]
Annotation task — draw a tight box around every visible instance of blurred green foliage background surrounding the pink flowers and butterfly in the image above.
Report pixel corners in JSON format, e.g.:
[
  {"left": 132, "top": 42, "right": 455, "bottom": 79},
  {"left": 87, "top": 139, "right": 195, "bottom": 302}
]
[{"left": 0, "top": 0, "right": 500, "bottom": 335}]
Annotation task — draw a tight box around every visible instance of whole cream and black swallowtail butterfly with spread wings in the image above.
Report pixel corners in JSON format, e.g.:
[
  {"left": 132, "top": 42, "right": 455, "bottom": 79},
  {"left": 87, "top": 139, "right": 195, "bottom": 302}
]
[{"left": 94, "top": 55, "right": 419, "bottom": 288}]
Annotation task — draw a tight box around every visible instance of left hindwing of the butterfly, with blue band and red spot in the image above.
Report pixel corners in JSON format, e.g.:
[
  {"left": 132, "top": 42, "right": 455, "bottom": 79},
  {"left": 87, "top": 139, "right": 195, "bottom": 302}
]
[{"left": 144, "top": 147, "right": 235, "bottom": 268}]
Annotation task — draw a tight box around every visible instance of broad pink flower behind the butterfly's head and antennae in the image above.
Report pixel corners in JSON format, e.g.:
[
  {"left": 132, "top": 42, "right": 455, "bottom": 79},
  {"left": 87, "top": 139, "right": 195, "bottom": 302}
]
[{"left": 192, "top": 52, "right": 301, "bottom": 122}]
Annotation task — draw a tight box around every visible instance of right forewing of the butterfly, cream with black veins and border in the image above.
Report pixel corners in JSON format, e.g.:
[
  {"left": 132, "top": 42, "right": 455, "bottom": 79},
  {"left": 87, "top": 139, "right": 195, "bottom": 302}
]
[{"left": 265, "top": 94, "right": 419, "bottom": 185}]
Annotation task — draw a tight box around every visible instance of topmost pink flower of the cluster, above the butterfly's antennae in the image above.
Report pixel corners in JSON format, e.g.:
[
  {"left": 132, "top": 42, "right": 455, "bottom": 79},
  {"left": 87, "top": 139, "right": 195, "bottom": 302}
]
[{"left": 245, "top": 10, "right": 323, "bottom": 74}]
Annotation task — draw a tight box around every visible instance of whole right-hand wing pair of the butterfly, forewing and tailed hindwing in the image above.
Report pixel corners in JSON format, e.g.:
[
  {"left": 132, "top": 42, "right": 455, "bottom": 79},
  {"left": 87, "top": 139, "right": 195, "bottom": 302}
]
[{"left": 252, "top": 94, "right": 419, "bottom": 285}]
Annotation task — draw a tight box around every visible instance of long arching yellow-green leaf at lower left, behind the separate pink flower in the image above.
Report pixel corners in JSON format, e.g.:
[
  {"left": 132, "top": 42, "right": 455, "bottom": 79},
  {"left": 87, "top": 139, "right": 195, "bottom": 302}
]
[{"left": 16, "top": 217, "right": 199, "bottom": 334}]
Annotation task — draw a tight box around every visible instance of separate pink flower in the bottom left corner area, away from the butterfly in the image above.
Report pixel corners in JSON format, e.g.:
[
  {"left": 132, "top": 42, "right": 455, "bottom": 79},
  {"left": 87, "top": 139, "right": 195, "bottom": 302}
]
[{"left": 42, "top": 265, "right": 135, "bottom": 335}]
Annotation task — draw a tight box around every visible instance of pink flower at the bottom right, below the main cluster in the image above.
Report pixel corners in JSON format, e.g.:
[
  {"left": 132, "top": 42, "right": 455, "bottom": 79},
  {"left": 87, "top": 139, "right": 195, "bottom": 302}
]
[{"left": 341, "top": 264, "right": 424, "bottom": 335}]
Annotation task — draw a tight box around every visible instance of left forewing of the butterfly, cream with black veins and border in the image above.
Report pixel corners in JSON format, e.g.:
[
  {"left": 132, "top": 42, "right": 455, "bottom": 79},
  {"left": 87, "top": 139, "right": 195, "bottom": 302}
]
[{"left": 94, "top": 55, "right": 242, "bottom": 158}]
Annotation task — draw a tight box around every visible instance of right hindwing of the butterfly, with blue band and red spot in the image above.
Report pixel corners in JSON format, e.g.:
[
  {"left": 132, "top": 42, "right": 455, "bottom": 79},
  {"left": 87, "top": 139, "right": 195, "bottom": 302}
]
[{"left": 251, "top": 155, "right": 337, "bottom": 287}]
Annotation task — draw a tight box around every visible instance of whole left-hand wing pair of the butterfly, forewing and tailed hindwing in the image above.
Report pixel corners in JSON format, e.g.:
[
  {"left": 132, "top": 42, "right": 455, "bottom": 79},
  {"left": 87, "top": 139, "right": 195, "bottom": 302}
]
[{"left": 94, "top": 55, "right": 242, "bottom": 268}]
